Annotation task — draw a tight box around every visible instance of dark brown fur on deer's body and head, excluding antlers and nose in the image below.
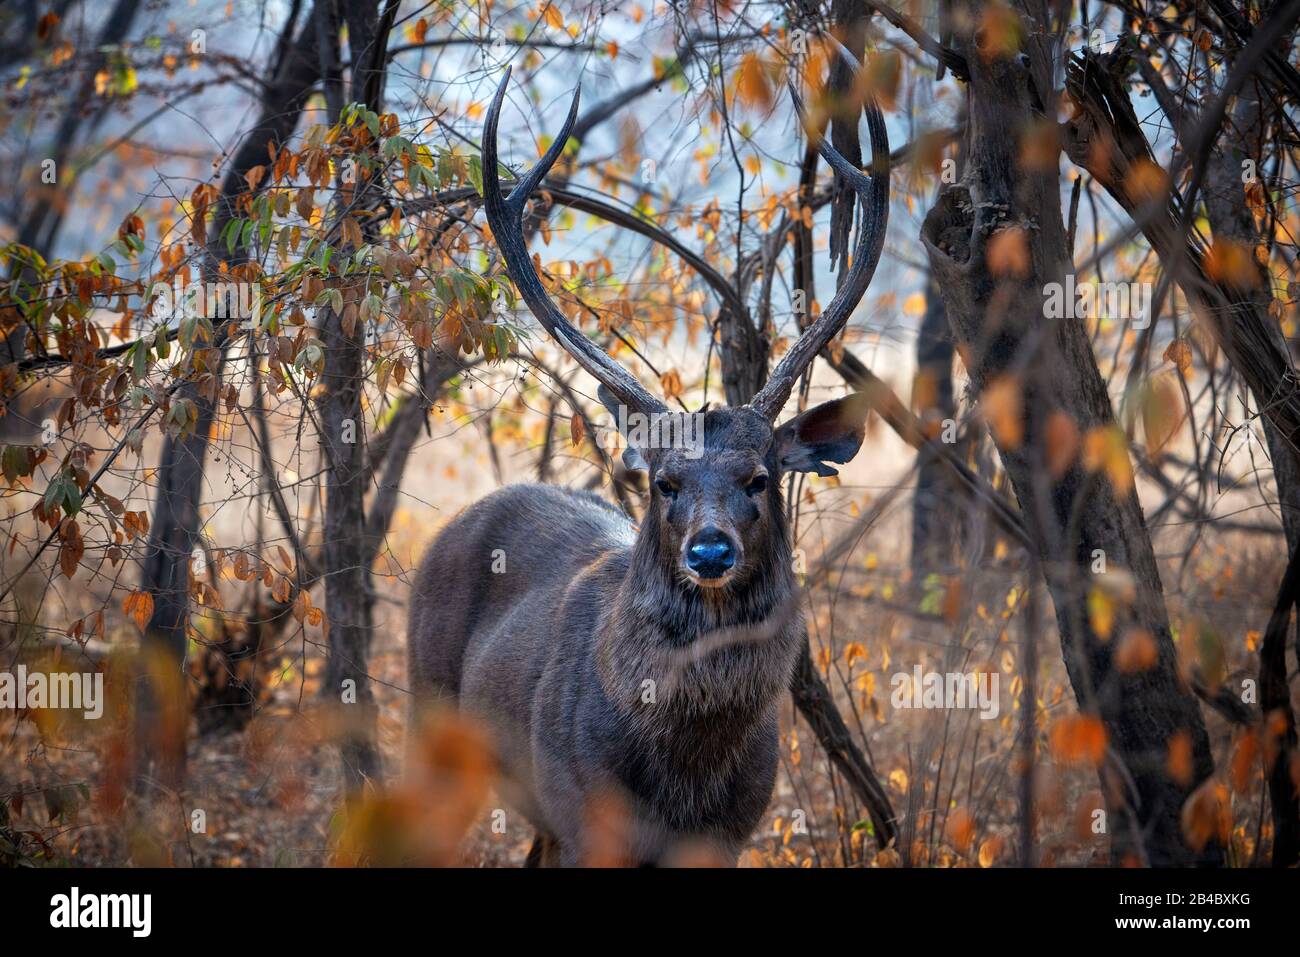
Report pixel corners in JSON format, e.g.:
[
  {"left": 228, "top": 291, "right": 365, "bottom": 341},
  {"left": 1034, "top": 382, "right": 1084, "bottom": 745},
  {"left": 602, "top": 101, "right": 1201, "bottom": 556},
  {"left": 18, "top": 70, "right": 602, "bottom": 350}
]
[{"left": 410, "top": 400, "right": 865, "bottom": 865}]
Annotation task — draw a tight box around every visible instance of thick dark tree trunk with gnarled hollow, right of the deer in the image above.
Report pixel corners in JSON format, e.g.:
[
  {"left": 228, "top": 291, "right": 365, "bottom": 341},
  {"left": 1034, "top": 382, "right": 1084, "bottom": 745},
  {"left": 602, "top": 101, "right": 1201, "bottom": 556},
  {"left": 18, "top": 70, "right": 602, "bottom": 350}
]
[{"left": 922, "top": 4, "right": 1221, "bottom": 866}]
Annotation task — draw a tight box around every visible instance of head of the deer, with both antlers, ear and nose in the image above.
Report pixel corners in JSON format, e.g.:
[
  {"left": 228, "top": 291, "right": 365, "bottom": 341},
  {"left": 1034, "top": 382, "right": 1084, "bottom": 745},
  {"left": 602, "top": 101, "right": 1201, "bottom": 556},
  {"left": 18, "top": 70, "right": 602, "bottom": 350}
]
[{"left": 482, "top": 57, "right": 889, "bottom": 590}]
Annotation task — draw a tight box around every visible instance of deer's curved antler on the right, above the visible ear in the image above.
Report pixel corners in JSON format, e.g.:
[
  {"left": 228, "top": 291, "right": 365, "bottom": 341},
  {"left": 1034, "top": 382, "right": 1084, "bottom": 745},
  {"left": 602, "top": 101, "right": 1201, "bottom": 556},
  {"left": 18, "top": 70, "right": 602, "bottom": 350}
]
[{"left": 750, "top": 48, "right": 889, "bottom": 421}]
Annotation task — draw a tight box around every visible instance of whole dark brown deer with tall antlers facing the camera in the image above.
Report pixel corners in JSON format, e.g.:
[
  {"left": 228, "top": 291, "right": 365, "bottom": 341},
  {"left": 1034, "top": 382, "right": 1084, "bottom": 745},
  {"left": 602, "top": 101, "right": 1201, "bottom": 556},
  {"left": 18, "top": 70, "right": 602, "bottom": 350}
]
[{"left": 408, "top": 59, "right": 889, "bottom": 866}]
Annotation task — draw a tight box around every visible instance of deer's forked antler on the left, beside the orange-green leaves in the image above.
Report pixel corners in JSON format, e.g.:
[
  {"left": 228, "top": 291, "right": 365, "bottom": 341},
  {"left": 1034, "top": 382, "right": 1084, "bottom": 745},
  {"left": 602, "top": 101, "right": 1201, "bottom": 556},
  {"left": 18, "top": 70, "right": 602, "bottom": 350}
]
[{"left": 482, "top": 66, "right": 668, "bottom": 415}]
